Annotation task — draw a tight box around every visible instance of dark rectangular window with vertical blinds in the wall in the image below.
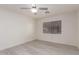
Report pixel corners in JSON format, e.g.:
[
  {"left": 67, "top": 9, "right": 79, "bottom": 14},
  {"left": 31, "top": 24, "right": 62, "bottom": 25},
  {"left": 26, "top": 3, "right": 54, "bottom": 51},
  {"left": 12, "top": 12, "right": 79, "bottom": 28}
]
[{"left": 43, "top": 20, "right": 61, "bottom": 34}]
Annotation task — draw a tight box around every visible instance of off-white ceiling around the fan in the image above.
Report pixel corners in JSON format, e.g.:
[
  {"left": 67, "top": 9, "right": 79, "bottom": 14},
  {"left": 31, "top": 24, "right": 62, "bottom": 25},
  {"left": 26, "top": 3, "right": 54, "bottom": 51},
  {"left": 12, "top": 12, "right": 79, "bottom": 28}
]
[{"left": 0, "top": 4, "right": 79, "bottom": 19}]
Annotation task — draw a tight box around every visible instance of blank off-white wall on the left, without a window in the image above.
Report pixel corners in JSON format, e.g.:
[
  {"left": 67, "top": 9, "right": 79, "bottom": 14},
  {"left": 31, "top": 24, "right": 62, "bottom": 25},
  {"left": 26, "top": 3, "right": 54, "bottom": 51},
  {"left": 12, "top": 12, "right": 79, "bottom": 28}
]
[{"left": 0, "top": 8, "right": 34, "bottom": 50}]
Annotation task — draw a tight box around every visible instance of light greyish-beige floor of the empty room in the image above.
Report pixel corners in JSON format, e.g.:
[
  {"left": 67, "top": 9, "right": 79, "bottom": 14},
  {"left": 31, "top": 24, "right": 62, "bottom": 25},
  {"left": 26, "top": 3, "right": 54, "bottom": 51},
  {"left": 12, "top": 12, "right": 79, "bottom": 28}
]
[{"left": 0, "top": 40, "right": 79, "bottom": 55}]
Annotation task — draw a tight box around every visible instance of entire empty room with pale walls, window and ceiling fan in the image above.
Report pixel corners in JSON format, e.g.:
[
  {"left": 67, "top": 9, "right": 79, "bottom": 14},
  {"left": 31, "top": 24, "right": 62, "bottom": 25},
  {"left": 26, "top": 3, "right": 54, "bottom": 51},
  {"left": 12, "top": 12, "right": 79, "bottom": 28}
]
[{"left": 0, "top": 4, "right": 79, "bottom": 55}]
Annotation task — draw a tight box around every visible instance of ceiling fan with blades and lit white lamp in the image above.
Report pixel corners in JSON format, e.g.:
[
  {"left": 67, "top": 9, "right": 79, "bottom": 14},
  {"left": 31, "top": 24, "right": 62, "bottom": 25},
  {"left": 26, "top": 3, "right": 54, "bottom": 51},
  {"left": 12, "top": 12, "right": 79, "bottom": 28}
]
[{"left": 21, "top": 4, "right": 49, "bottom": 15}]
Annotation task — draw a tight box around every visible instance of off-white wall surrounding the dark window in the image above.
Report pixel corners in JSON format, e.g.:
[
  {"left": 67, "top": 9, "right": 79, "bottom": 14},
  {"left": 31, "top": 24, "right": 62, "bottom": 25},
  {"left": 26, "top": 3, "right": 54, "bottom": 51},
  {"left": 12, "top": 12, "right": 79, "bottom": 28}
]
[{"left": 36, "top": 12, "right": 77, "bottom": 46}]
